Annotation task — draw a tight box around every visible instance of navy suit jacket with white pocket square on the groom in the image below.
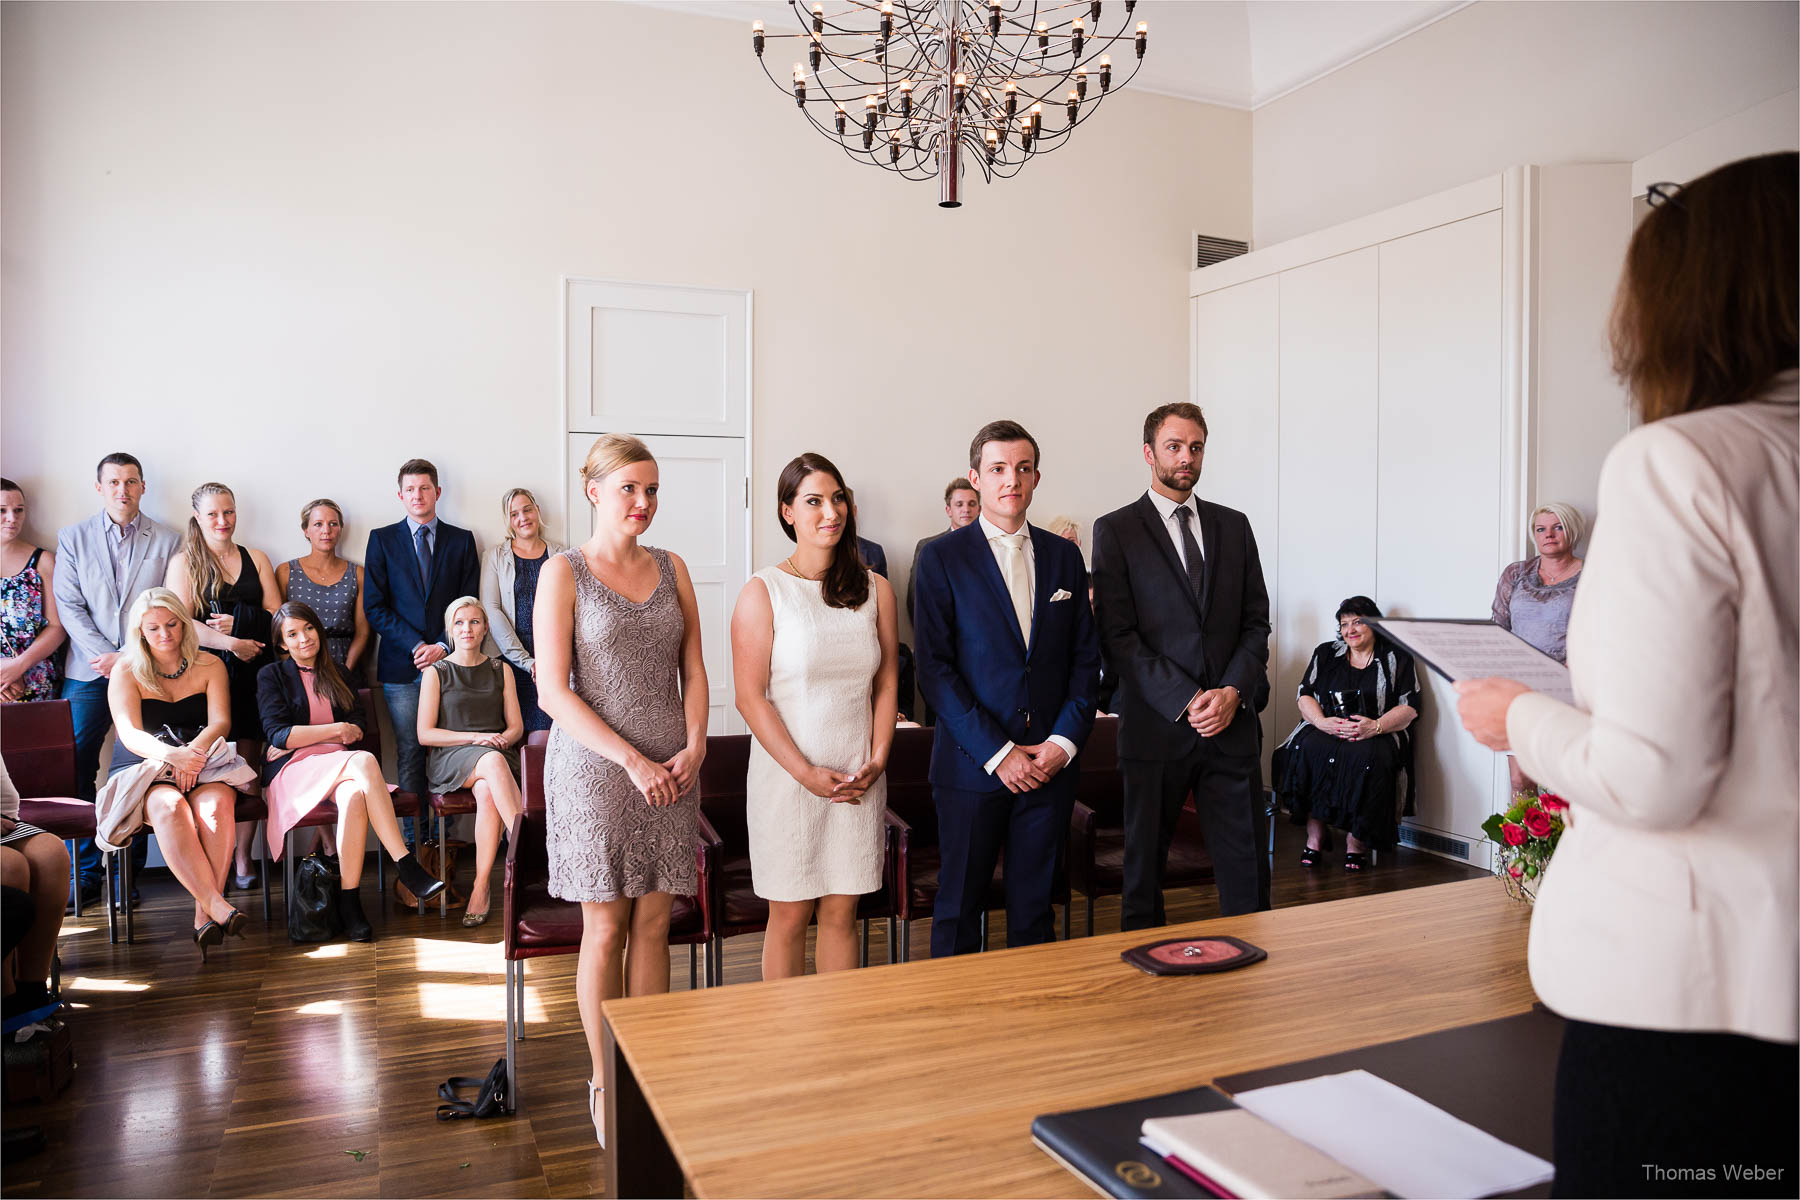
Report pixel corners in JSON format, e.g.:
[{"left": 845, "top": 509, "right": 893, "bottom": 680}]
[{"left": 913, "top": 522, "right": 1100, "bottom": 792}]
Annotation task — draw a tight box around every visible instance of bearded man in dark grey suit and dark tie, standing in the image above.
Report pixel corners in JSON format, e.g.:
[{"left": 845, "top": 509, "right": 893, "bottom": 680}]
[{"left": 1094, "top": 403, "right": 1269, "bottom": 928}]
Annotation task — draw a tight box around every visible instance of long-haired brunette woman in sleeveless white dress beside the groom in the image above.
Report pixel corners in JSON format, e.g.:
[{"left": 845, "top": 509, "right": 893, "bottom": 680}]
[{"left": 731, "top": 453, "right": 900, "bottom": 979}]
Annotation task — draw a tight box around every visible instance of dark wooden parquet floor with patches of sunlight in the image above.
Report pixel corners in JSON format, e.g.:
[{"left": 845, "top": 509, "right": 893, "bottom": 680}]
[{"left": 0, "top": 824, "right": 1480, "bottom": 1196}]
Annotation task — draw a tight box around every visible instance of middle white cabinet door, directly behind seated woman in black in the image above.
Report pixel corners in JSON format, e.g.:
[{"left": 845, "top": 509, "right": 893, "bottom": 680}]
[{"left": 1269, "top": 246, "right": 1382, "bottom": 752}]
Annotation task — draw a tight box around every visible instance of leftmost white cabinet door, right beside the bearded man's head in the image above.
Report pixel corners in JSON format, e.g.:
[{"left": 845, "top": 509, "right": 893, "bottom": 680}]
[{"left": 1190, "top": 275, "right": 1285, "bottom": 777}]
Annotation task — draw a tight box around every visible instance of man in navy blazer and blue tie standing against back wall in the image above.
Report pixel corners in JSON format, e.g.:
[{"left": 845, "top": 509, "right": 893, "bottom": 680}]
[{"left": 362, "top": 459, "right": 481, "bottom": 824}]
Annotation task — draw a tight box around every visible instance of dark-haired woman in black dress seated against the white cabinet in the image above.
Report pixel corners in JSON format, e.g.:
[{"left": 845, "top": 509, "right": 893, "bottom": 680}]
[{"left": 1274, "top": 596, "right": 1420, "bottom": 871}]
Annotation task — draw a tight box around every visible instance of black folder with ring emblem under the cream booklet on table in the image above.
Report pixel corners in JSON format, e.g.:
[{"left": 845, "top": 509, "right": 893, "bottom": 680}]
[{"left": 1031, "top": 1087, "right": 1237, "bottom": 1200}]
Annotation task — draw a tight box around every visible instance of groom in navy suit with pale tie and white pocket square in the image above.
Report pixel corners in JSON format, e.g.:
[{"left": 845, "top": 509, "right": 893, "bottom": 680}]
[{"left": 913, "top": 421, "right": 1100, "bottom": 957}]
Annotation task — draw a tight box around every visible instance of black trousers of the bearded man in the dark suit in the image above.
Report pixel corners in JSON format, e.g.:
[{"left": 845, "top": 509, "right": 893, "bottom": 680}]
[{"left": 1120, "top": 739, "right": 1269, "bottom": 930}]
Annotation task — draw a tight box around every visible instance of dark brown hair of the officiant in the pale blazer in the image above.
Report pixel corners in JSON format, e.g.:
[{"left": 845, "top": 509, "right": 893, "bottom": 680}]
[{"left": 1611, "top": 151, "right": 1800, "bottom": 421}]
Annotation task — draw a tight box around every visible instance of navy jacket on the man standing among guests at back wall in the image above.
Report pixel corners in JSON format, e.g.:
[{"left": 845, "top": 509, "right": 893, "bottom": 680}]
[{"left": 362, "top": 518, "right": 481, "bottom": 684}]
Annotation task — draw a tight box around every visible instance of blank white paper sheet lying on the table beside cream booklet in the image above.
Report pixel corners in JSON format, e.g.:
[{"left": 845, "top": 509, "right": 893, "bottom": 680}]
[{"left": 1231, "top": 1070, "right": 1555, "bottom": 1200}]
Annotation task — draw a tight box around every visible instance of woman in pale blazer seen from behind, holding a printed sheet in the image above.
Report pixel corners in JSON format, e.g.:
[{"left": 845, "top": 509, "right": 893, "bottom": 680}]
[{"left": 1458, "top": 153, "right": 1800, "bottom": 1196}]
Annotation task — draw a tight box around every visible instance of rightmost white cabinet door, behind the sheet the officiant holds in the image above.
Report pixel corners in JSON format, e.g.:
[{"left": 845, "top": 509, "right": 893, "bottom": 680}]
[{"left": 1375, "top": 212, "right": 1507, "bottom": 865}]
